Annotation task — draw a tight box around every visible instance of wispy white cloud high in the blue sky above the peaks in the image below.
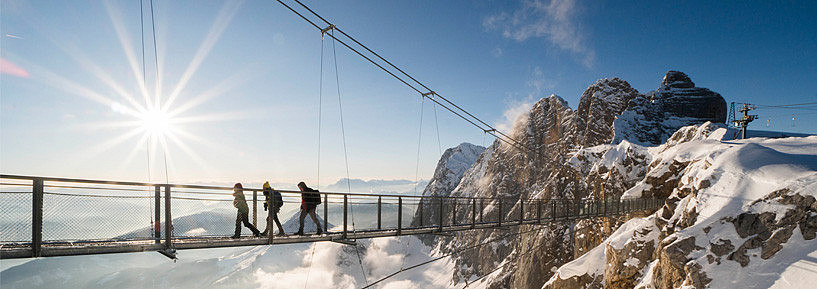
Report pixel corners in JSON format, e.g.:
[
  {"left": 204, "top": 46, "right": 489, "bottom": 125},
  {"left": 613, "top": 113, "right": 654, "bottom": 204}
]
[{"left": 482, "top": 0, "right": 595, "bottom": 67}]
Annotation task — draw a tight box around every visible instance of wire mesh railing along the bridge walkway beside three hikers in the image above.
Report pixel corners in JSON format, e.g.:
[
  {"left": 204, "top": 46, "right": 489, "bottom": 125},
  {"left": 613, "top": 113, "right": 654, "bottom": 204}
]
[{"left": 0, "top": 175, "right": 663, "bottom": 257}]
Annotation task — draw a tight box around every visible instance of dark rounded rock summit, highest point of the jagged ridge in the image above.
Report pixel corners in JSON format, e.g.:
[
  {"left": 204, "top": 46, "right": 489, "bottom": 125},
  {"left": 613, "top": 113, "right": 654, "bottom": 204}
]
[{"left": 614, "top": 71, "right": 726, "bottom": 145}]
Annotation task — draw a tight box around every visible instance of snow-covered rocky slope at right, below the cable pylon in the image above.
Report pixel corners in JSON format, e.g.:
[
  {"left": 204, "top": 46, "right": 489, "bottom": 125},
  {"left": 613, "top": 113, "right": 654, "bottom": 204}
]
[{"left": 544, "top": 123, "right": 817, "bottom": 288}]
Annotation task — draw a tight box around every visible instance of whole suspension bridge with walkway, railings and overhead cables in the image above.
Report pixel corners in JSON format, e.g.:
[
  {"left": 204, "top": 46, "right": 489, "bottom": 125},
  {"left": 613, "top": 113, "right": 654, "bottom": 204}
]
[{"left": 0, "top": 0, "right": 663, "bottom": 259}]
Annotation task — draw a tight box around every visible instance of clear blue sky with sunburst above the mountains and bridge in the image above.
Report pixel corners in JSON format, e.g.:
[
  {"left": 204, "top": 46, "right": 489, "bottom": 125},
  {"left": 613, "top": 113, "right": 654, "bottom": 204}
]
[{"left": 0, "top": 0, "right": 817, "bottom": 185}]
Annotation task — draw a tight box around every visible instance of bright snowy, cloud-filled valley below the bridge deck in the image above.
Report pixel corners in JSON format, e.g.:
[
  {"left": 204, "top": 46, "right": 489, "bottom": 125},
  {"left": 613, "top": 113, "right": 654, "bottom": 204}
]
[{"left": 0, "top": 236, "right": 454, "bottom": 289}]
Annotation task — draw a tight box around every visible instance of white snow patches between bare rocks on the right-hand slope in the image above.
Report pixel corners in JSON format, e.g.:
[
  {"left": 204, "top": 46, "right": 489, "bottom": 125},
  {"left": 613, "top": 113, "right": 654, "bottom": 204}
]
[{"left": 548, "top": 123, "right": 817, "bottom": 288}]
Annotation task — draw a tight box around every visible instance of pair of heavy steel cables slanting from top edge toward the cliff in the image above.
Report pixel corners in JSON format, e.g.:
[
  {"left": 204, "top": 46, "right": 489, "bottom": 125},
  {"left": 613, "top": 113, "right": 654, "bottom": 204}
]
[{"left": 276, "top": 0, "right": 533, "bottom": 153}]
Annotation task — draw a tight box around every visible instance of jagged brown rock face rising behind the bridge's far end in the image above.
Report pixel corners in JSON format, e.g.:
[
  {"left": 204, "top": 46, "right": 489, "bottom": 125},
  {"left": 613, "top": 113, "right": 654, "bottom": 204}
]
[{"left": 415, "top": 72, "right": 726, "bottom": 288}]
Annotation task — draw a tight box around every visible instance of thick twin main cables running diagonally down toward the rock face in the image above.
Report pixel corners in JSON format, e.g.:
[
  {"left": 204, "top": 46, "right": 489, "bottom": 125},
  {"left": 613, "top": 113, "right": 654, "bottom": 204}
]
[{"left": 276, "top": 0, "right": 533, "bottom": 153}]
